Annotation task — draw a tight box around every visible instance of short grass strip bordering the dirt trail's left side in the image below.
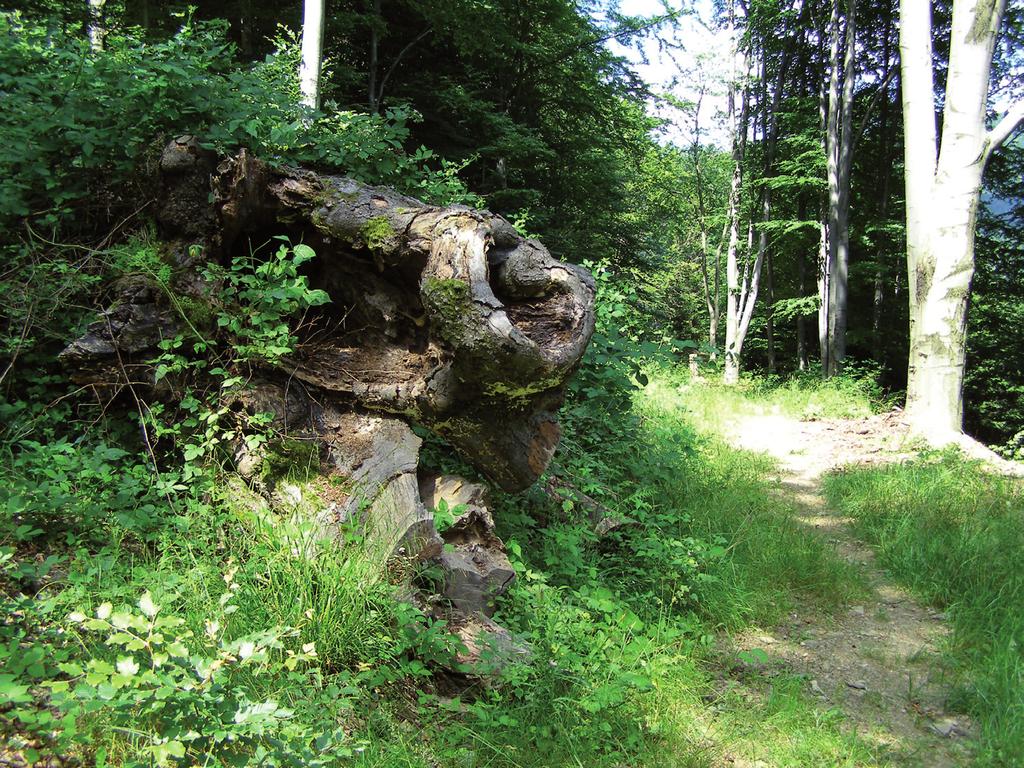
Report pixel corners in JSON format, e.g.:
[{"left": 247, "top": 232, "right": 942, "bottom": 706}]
[{"left": 638, "top": 372, "right": 867, "bottom": 628}]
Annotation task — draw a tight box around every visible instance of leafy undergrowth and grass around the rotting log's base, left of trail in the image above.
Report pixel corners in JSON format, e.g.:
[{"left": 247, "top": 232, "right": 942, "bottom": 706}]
[{"left": 0, "top": 250, "right": 876, "bottom": 768}]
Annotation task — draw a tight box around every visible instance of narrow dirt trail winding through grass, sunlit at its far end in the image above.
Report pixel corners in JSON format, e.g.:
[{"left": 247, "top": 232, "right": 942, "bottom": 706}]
[{"left": 729, "top": 413, "right": 974, "bottom": 768}]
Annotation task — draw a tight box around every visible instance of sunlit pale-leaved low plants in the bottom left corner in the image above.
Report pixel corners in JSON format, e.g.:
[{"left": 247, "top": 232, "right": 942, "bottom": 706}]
[{"left": 55, "top": 571, "right": 352, "bottom": 766}]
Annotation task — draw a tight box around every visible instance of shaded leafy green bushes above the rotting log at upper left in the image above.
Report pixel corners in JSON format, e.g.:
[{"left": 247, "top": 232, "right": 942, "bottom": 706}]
[{"left": 0, "top": 12, "right": 475, "bottom": 237}]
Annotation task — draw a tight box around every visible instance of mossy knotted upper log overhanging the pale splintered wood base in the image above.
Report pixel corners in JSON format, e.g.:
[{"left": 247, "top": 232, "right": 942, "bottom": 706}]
[{"left": 193, "top": 147, "right": 594, "bottom": 490}]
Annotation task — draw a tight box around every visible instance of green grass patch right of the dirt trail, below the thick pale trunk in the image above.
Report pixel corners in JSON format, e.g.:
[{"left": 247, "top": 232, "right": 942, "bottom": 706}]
[{"left": 825, "top": 454, "right": 1024, "bottom": 766}]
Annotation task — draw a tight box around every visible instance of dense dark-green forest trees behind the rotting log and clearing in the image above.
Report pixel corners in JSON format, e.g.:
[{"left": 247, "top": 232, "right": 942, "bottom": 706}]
[{"left": 4, "top": 2, "right": 1024, "bottom": 444}]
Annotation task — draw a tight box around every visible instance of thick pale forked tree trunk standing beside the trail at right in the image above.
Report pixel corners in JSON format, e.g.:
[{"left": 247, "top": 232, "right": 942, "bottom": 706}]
[{"left": 900, "top": 0, "right": 1024, "bottom": 444}]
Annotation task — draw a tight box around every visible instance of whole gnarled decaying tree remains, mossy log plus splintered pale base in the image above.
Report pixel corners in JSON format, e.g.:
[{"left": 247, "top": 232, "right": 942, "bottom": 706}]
[{"left": 61, "top": 137, "right": 594, "bottom": 671}]
